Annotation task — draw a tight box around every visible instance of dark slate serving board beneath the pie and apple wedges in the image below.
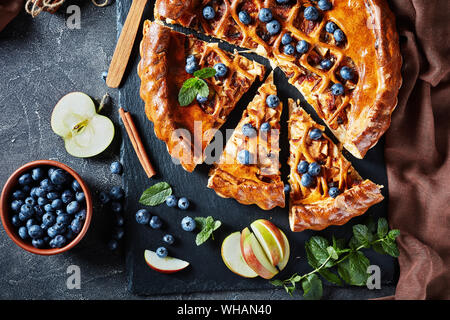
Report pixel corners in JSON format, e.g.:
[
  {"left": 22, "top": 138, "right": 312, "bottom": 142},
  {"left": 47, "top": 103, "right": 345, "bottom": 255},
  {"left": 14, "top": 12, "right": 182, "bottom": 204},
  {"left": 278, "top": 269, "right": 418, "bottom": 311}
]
[{"left": 116, "top": 0, "right": 396, "bottom": 295}]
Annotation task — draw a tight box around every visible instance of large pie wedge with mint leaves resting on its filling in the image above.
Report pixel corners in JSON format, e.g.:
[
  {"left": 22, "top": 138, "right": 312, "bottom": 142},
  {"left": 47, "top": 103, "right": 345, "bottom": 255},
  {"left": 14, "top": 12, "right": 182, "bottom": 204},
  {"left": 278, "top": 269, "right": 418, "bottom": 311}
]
[{"left": 138, "top": 21, "right": 265, "bottom": 172}]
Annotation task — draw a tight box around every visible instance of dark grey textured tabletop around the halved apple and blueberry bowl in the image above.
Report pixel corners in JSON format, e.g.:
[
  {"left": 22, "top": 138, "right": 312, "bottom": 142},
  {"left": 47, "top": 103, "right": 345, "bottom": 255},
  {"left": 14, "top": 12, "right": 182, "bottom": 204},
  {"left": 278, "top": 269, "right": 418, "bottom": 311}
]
[{"left": 0, "top": 1, "right": 394, "bottom": 300}]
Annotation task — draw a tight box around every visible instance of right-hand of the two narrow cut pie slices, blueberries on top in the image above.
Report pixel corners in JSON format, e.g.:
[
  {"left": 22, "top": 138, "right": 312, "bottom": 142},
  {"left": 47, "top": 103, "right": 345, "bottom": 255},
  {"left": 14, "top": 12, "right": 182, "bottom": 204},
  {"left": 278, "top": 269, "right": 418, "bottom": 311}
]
[{"left": 289, "top": 99, "right": 383, "bottom": 231}]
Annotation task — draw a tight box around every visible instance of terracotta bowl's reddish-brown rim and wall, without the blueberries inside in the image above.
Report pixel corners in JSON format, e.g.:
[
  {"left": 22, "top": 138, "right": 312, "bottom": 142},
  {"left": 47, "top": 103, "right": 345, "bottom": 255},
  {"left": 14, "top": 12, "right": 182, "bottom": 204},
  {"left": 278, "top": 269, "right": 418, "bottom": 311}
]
[{"left": 0, "top": 160, "right": 92, "bottom": 256}]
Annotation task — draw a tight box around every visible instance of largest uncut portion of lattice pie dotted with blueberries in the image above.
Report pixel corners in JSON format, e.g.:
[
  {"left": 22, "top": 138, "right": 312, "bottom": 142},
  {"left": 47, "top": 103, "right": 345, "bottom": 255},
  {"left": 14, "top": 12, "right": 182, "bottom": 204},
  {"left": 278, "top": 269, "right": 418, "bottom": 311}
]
[{"left": 155, "top": 0, "right": 402, "bottom": 159}]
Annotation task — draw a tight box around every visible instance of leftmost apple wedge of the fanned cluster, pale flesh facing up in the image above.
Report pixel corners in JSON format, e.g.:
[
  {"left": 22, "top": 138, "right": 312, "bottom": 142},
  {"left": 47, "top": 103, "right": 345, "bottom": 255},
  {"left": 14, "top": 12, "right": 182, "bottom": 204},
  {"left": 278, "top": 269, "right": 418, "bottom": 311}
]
[{"left": 221, "top": 231, "right": 258, "bottom": 278}]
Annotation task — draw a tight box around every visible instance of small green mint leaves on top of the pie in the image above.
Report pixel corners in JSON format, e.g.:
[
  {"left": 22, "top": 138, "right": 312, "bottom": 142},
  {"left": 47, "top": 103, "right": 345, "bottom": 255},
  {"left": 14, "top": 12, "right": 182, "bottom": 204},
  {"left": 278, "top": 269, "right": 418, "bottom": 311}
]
[{"left": 178, "top": 67, "right": 216, "bottom": 107}]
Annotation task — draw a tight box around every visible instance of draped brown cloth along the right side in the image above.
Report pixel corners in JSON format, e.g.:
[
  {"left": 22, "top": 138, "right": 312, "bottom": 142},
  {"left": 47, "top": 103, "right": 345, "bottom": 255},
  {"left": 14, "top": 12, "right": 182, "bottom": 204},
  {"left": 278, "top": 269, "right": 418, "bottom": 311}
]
[{"left": 385, "top": 0, "right": 450, "bottom": 299}]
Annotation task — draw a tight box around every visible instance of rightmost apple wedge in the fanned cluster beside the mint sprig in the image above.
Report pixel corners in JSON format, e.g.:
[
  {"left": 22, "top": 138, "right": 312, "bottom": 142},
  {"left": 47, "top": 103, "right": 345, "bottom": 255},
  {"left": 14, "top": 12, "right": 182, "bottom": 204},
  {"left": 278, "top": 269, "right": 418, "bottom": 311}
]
[{"left": 250, "top": 219, "right": 285, "bottom": 266}]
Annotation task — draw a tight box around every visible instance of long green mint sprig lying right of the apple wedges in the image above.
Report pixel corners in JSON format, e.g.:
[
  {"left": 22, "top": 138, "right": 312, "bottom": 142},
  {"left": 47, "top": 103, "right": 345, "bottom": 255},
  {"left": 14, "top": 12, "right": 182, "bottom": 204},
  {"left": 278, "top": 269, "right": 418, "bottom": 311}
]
[{"left": 271, "top": 218, "right": 400, "bottom": 300}]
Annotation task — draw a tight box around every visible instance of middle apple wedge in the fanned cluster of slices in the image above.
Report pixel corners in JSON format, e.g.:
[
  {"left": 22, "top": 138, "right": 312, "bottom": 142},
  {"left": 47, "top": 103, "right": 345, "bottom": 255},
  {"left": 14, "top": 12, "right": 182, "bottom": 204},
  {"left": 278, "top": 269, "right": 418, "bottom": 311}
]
[{"left": 241, "top": 228, "right": 278, "bottom": 279}]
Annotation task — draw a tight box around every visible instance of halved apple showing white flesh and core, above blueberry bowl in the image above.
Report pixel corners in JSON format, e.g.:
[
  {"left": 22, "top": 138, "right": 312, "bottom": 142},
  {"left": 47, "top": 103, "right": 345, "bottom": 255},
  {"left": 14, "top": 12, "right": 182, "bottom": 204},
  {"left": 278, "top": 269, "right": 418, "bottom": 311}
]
[{"left": 51, "top": 92, "right": 115, "bottom": 158}]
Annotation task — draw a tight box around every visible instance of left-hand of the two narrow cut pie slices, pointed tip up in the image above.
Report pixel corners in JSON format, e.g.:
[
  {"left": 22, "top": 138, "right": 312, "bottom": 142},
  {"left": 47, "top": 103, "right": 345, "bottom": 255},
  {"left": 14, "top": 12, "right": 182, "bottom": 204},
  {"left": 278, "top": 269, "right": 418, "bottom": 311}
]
[{"left": 208, "top": 73, "right": 285, "bottom": 210}]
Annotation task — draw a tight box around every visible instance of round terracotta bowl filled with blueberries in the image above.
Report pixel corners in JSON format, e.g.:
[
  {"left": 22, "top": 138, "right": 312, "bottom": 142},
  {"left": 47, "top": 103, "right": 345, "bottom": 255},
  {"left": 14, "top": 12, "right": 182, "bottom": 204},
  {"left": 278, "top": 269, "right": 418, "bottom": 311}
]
[{"left": 0, "top": 160, "right": 92, "bottom": 255}]
